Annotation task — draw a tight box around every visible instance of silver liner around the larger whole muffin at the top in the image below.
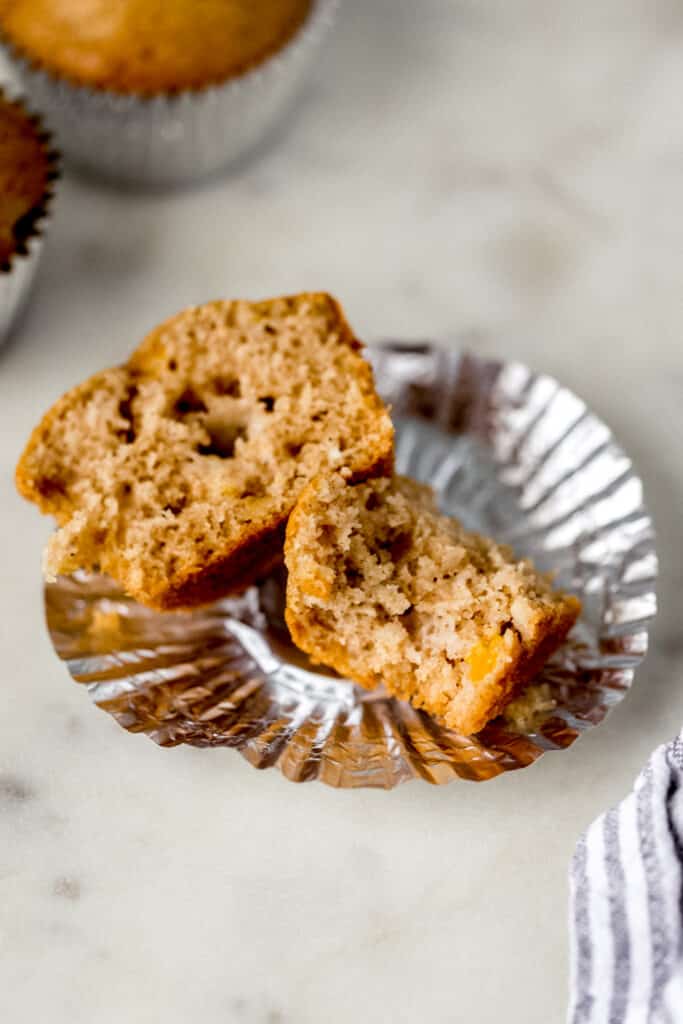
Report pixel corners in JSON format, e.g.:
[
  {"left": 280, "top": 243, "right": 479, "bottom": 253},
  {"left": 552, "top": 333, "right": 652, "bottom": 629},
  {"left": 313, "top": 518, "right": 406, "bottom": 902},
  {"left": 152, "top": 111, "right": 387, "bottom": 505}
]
[{"left": 4, "top": 0, "right": 338, "bottom": 186}]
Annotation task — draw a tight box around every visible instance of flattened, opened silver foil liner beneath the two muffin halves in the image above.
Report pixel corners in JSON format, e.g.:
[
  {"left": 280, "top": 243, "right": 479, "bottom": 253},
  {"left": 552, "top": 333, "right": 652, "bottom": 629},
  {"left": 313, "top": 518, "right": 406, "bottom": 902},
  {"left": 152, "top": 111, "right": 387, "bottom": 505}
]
[{"left": 45, "top": 344, "right": 657, "bottom": 788}]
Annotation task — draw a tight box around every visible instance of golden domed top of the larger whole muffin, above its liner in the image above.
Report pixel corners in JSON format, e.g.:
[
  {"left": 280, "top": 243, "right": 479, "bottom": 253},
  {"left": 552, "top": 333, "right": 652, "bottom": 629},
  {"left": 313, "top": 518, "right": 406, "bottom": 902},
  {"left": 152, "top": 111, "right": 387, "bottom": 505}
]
[{"left": 0, "top": 0, "right": 312, "bottom": 95}]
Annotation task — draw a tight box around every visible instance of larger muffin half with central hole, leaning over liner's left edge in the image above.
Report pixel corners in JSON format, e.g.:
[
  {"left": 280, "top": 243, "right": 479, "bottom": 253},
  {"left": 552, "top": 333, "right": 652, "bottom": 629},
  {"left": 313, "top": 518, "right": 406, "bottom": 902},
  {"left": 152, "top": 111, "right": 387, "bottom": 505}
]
[{"left": 16, "top": 294, "right": 393, "bottom": 609}]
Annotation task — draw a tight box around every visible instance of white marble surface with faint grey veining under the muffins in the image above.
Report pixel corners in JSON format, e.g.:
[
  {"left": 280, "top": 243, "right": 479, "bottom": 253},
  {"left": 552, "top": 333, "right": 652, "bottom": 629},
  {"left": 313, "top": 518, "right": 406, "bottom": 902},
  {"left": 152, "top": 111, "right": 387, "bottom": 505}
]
[{"left": 0, "top": 0, "right": 683, "bottom": 1024}]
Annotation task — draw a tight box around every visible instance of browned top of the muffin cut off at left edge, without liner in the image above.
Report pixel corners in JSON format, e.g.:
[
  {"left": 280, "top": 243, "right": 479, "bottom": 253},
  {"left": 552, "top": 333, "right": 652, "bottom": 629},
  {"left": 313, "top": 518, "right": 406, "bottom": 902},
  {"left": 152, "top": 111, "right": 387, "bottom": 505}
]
[{"left": 0, "top": 92, "right": 50, "bottom": 270}]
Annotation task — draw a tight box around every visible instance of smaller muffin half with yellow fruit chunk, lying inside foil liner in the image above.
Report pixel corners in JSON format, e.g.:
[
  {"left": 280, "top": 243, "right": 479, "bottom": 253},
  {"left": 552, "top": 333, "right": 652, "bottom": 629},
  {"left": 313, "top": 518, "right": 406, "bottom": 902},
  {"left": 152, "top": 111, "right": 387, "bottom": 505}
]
[{"left": 285, "top": 472, "right": 581, "bottom": 735}]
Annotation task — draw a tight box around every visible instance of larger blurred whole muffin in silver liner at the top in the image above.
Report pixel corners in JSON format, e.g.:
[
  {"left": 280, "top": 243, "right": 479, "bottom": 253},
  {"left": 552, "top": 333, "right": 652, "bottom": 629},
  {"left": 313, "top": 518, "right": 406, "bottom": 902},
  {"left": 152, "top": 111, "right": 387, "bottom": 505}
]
[{"left": 0, "top": 0, "right": 335, "bottom": 183}]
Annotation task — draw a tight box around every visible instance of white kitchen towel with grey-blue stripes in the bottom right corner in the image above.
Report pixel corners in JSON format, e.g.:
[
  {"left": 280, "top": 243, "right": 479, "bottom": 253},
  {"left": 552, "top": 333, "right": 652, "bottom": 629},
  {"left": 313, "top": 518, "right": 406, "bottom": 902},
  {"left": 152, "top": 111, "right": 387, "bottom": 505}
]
[{"left": 568, "top": 733, "right": 683, "bottom": 1024}]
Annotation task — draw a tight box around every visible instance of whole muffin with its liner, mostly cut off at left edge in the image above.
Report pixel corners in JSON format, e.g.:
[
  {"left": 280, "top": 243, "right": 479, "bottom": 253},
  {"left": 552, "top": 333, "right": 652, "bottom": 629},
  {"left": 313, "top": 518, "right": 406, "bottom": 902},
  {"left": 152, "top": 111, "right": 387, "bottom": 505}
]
[{"left": 0, "top": 90, "right": 57, "bottom": 343}]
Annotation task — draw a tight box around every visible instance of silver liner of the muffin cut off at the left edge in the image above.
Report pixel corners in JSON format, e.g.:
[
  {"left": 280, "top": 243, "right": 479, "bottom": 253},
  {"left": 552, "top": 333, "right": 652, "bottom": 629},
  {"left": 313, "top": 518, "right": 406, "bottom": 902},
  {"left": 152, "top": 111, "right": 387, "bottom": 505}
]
[{"left": 0, "top": 89, "right": 59, "bottom": 347}]
